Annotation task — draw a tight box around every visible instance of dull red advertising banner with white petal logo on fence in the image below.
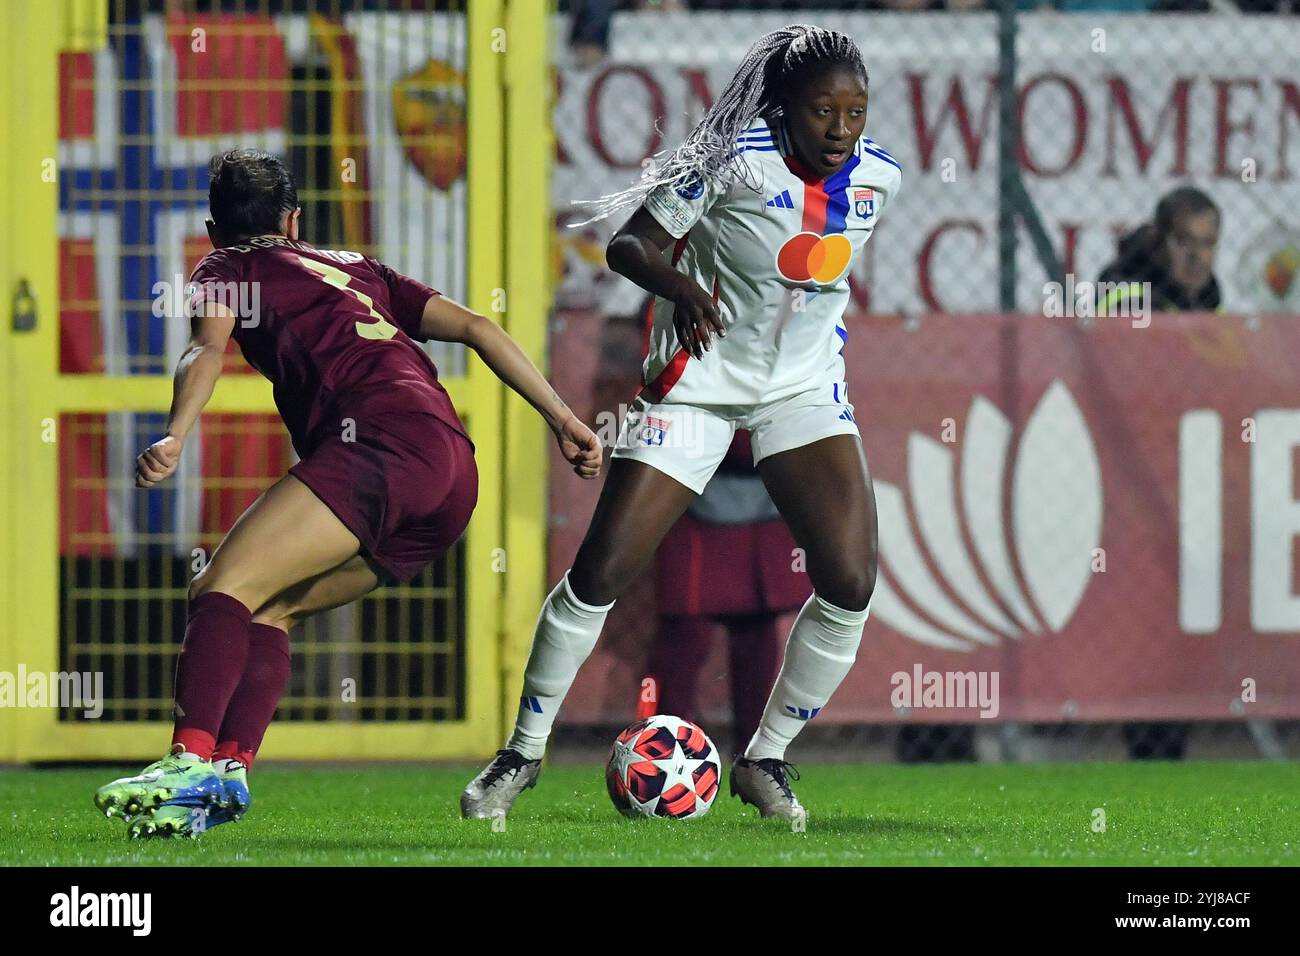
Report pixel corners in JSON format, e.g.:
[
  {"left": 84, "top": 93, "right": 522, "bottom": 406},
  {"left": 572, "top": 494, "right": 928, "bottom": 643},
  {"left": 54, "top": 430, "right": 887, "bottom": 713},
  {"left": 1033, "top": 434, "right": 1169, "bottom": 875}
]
[{"left": 550, "top": 312, "right": 1300, "bottom": 723}]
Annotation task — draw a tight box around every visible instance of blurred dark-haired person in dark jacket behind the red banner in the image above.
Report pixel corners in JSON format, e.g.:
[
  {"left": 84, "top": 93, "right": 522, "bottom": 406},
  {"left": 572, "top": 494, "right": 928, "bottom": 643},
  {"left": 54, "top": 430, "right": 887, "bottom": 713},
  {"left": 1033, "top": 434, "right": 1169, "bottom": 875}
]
[{"left": 1097, "top": 186, "right": 1222, "bottom": 315}]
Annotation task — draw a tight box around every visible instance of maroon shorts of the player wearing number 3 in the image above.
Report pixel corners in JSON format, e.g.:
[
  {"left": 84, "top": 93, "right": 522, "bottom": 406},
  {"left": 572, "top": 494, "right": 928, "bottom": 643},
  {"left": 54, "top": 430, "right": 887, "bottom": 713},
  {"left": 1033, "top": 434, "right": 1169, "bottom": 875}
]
[{"left": 289, "top": 411, "right": 478, "bottom": 581}]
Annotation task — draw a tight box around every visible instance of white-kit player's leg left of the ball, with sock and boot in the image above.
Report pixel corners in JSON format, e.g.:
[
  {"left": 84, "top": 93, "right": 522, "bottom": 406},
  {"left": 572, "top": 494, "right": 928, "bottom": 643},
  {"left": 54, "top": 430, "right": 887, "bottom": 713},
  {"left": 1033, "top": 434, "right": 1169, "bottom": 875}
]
[{"left": 460, "top": 458, "right": 696, "bottom": 819}]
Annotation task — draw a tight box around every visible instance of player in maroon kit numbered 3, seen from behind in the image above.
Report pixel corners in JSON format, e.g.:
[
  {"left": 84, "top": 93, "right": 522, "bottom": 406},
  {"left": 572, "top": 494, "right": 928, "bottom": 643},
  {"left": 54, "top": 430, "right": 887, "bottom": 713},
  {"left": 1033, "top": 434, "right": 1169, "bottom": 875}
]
[{"left": 95, "top": 150, "right": 602, "bottom": 836}]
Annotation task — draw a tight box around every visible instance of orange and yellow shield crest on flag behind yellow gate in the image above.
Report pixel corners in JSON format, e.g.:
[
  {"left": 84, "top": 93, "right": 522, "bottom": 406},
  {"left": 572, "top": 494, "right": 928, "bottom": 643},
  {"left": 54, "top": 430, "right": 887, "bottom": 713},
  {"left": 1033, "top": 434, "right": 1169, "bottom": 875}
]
[{"left": 393, "top": 60, "right": 465, "bottom": 190}]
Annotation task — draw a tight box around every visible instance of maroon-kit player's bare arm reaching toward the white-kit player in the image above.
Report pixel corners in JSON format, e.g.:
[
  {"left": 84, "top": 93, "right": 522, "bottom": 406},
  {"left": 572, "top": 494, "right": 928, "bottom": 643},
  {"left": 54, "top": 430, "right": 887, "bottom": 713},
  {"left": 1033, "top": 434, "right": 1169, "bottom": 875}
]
[{"left": 420, "top": 295, "right": 603, "bottom": 479}]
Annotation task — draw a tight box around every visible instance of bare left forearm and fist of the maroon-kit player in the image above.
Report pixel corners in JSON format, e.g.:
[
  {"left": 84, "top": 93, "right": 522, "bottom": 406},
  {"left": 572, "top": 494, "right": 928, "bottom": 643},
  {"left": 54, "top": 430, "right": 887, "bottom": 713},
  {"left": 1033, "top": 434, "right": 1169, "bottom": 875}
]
[{"left": 135, "top": 302, "right": 235, "bottom": 488}]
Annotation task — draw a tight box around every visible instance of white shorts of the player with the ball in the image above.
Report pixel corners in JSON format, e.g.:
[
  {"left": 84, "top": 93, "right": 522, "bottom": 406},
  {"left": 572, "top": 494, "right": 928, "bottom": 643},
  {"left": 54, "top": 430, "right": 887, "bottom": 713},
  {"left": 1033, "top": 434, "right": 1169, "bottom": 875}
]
[{"left": 610, "top": 389, "right": 858, "bottom": 494}]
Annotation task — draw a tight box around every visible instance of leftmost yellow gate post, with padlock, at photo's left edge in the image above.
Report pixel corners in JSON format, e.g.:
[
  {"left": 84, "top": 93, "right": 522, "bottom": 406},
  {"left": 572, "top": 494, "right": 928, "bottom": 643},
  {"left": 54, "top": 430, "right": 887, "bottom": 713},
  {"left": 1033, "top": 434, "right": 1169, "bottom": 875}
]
[{"left": 0, "top": 0, "right": 87, "bottom": 760}]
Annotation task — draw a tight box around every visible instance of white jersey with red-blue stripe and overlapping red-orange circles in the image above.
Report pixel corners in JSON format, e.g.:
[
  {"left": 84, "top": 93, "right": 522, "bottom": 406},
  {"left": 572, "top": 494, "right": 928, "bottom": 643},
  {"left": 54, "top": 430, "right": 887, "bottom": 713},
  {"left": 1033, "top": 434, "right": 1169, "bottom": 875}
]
[{"left": 642, "top": 120, "right": 902, "bottom": 406}]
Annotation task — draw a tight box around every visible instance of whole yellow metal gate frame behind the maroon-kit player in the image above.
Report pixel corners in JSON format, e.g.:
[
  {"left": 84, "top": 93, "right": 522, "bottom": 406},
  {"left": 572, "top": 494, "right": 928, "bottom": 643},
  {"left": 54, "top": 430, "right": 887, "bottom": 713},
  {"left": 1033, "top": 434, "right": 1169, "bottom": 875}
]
[{"left": 0, "top": 0, "right": 551, "bottom": 762}]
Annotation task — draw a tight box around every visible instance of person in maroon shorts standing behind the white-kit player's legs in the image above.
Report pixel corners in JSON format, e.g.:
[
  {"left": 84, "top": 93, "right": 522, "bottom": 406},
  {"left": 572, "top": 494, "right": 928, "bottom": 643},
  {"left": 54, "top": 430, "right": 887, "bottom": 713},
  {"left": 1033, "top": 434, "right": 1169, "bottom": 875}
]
[{"left": 637, "top": 431, "right": 813, "bottom": 757}]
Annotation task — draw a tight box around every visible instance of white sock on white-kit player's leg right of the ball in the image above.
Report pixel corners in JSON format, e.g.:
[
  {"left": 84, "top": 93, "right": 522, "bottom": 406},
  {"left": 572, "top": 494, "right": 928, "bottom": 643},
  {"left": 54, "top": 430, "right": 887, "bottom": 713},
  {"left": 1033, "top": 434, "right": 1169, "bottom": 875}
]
[{"left": 745, "top": 594, "right": 871, "bottom": 760}]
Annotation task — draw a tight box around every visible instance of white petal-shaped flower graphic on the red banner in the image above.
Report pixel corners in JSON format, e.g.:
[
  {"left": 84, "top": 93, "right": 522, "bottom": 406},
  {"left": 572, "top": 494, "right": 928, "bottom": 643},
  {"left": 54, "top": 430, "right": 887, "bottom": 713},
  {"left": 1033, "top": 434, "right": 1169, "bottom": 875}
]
[{"left": 871, "top": 380, "right": 1102, "bottom": 650}]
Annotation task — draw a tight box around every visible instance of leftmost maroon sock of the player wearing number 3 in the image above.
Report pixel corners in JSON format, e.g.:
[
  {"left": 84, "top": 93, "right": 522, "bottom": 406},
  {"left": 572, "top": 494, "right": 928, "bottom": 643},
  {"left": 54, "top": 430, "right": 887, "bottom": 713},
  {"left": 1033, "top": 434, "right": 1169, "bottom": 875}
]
[{"left": 172, "top": 591, "right": 252, "bottom": 760}]
